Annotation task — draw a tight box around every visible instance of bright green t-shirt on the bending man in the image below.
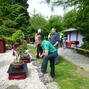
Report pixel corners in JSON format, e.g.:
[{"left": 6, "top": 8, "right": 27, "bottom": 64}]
[{"left": 42, "top": 40, "right": 56, "bottom": 54}]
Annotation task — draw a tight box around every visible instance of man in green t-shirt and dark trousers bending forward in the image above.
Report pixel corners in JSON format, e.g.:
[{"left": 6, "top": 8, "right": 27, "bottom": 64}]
[{"left": 35, "top": 36, "right": 58, "bottom": 78}]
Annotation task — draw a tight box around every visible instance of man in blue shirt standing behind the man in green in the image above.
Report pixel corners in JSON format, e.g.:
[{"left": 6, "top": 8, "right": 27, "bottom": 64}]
[{"left": 50, "top": 28, "right": 60, "bottom": 64}]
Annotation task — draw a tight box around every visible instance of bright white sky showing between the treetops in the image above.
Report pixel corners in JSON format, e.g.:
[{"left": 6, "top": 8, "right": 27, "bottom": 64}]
[{"left": 28, "top": 0, "right": 64, "bottom": 17}]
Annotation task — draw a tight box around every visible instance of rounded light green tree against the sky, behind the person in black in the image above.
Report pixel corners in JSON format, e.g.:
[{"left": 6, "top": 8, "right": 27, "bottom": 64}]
[{"left": 27, "top": 14, "right": 47, "bottom": 38}]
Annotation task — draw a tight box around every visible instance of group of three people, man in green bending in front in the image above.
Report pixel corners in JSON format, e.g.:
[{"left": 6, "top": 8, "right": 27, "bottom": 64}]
[{"left": 35, "top": 28, "right": 60, "bottom": 78}]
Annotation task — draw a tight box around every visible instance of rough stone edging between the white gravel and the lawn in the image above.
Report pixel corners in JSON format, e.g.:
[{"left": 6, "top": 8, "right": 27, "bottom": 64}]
[{"left": 32, "top": 61, "right": 60, "bottom": 89}]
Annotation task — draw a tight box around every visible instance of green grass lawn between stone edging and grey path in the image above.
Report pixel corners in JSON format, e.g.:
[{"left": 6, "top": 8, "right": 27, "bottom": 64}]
[{"left": 28, "top": 45, "right": 89, "bottom": 89}]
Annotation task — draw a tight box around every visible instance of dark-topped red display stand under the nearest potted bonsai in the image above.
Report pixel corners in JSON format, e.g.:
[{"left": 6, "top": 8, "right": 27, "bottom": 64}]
[{"left": 7, "top": 64, "right": 28, "bottom": 80}]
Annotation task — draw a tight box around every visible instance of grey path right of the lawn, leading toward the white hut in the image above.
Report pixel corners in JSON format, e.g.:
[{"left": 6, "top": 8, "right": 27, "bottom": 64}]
[{"left": 58, "top": 48, "right": 89, "bottom": 71}]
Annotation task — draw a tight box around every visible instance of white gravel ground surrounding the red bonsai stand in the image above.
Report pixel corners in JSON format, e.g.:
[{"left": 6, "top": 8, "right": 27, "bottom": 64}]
[{"left": 0, "top": 51, "right": 59, "bottom": 89}]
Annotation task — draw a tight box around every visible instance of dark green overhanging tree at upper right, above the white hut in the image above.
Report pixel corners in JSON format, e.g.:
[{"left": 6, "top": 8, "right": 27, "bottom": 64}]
[{"left": 46, "top": 0, "right": 89, "bottom": 47}]
